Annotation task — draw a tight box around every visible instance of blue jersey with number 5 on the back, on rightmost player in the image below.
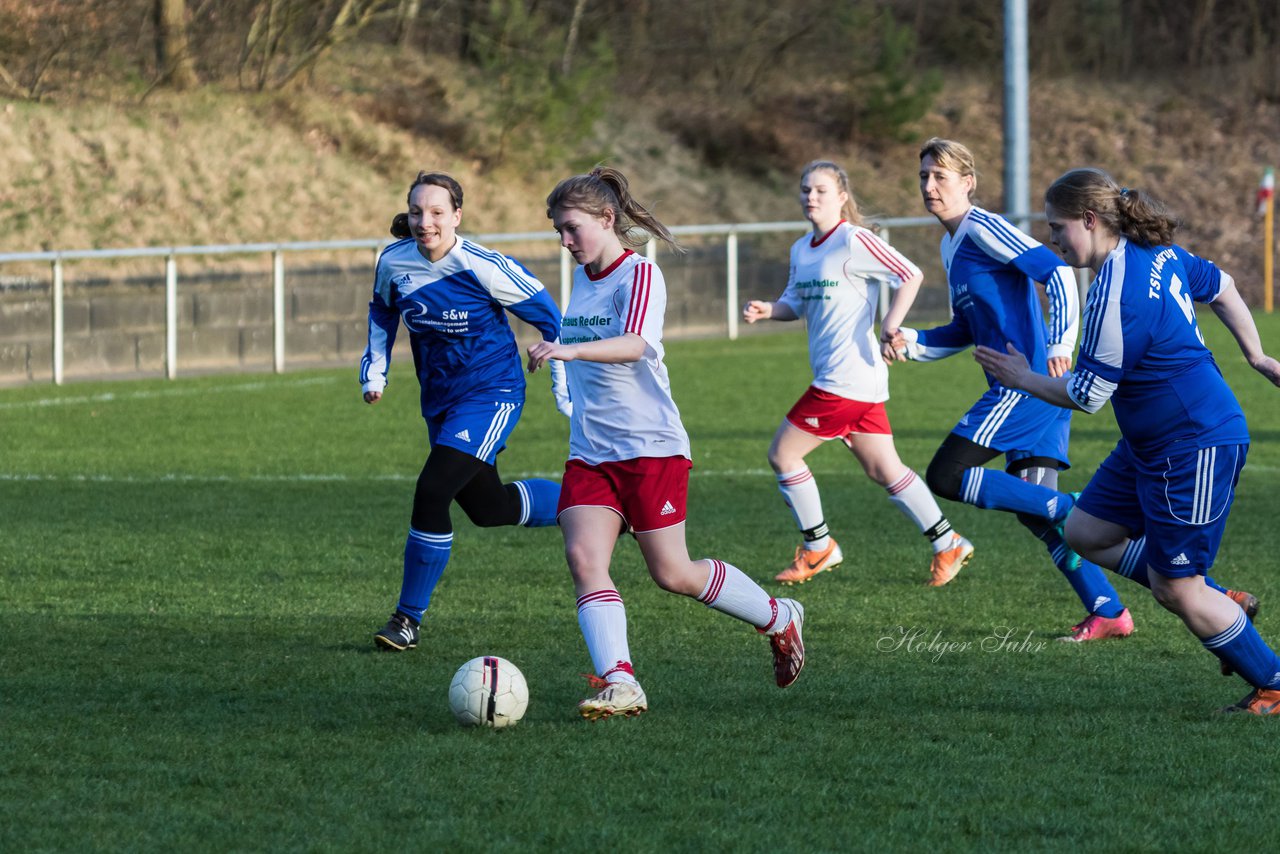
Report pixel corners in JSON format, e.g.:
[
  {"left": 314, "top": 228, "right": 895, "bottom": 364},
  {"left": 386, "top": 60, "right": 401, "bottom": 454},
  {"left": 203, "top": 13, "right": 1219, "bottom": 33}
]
[{"left": 1068, "top": 237, "right": 1249, "bottom": 460}]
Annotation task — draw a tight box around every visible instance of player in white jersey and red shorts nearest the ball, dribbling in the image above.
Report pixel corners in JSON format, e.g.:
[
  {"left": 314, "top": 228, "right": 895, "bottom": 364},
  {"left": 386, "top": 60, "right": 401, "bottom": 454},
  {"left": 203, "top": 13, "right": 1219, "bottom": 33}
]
[{"left": 529, "top": 168, "right": 804, "bottom": 720}]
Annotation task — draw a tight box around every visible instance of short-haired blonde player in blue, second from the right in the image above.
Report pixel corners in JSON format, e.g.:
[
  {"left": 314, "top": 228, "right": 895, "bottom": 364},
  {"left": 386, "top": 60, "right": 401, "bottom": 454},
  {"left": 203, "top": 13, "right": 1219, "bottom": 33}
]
[{"left": 882, "top": 138, "right": 1133, "bottom": 643}]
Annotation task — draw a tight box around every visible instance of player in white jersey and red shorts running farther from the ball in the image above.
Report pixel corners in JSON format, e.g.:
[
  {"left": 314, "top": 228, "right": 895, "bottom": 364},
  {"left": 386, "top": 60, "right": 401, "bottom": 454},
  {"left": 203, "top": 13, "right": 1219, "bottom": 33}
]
[{"left": 742, "top": 160, "right": 973, "bottom": 586}]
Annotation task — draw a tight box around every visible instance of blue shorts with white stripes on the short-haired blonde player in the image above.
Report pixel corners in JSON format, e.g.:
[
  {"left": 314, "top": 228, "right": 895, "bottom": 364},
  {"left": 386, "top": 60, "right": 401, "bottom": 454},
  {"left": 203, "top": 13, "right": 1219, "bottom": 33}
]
[{"left": 951, "top": 385, "right": 1071, "bottom": 469}]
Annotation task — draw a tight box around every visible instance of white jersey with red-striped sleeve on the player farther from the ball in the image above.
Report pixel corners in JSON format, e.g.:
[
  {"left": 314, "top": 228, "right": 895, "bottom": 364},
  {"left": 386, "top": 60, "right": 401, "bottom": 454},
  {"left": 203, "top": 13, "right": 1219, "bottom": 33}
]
[{"left": 778, "top": 220, "right": 920, "bottom": 403}]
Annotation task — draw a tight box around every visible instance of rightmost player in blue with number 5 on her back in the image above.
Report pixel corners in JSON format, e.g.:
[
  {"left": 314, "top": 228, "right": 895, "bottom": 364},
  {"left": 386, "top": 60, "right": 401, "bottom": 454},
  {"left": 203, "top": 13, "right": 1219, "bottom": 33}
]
[{"left": 975, "top": 169, "right": 1280, "bottom": 714}]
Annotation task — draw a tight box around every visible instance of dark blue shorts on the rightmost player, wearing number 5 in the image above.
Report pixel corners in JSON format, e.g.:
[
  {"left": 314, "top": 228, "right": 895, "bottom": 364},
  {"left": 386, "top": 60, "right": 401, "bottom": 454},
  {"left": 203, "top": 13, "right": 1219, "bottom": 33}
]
[{"left": 1076, "top": 439, "right": 1249, "bottom": 579}]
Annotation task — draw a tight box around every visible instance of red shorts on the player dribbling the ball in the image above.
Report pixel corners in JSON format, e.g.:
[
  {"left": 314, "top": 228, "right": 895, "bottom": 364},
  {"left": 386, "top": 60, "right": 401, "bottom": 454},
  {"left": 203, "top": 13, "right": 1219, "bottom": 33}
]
[{"left": 556, "top": 457, "right": 694, "bottom": 534}]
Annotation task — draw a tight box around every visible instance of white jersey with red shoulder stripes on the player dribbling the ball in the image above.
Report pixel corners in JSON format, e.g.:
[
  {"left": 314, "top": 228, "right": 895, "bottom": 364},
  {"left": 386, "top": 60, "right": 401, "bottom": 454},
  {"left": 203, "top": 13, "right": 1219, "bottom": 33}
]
[{"left": 561, "top": 250, "right": 691, "bottom": 465}]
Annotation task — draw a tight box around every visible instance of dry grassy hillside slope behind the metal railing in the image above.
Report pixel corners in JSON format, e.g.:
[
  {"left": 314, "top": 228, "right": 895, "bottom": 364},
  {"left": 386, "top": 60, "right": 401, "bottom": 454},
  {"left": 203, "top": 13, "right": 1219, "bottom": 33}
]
[{"left": 0, "top": 50, "right": 1280, "bottom": 300}]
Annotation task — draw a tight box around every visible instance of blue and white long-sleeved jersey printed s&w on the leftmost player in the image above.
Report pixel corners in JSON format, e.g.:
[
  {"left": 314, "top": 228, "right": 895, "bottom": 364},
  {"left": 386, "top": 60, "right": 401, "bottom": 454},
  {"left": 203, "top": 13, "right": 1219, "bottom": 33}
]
[{"left": 360, "top": 236, "right": 561, "bottom": 421}]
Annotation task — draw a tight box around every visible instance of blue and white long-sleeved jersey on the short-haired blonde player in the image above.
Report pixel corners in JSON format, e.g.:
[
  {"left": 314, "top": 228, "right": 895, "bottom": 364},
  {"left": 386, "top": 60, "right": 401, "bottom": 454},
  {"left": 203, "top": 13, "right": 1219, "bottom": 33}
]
[{"left": 910, "top": 207, "right": 1079, "bottom": 378}]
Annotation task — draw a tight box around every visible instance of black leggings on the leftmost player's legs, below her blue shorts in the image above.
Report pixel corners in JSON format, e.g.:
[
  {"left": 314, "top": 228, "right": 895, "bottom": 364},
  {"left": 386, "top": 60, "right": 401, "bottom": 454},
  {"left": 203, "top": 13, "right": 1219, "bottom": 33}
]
[{"left": 410, "top": 444, "right": 524, "bottom": 534}]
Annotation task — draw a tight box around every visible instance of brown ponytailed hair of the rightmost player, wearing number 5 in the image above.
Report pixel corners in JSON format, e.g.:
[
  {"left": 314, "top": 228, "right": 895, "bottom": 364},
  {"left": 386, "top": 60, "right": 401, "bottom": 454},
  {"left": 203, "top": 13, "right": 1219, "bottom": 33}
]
[{"left": 1044, "top": 168, "right": 1180, "bottom": 246}]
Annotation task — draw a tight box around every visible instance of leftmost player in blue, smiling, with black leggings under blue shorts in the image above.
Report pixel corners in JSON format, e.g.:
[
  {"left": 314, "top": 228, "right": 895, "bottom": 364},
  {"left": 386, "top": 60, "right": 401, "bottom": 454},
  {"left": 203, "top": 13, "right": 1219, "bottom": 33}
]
[{"left": 360, "top": 172, "right": 567, "bottom": 650}]
